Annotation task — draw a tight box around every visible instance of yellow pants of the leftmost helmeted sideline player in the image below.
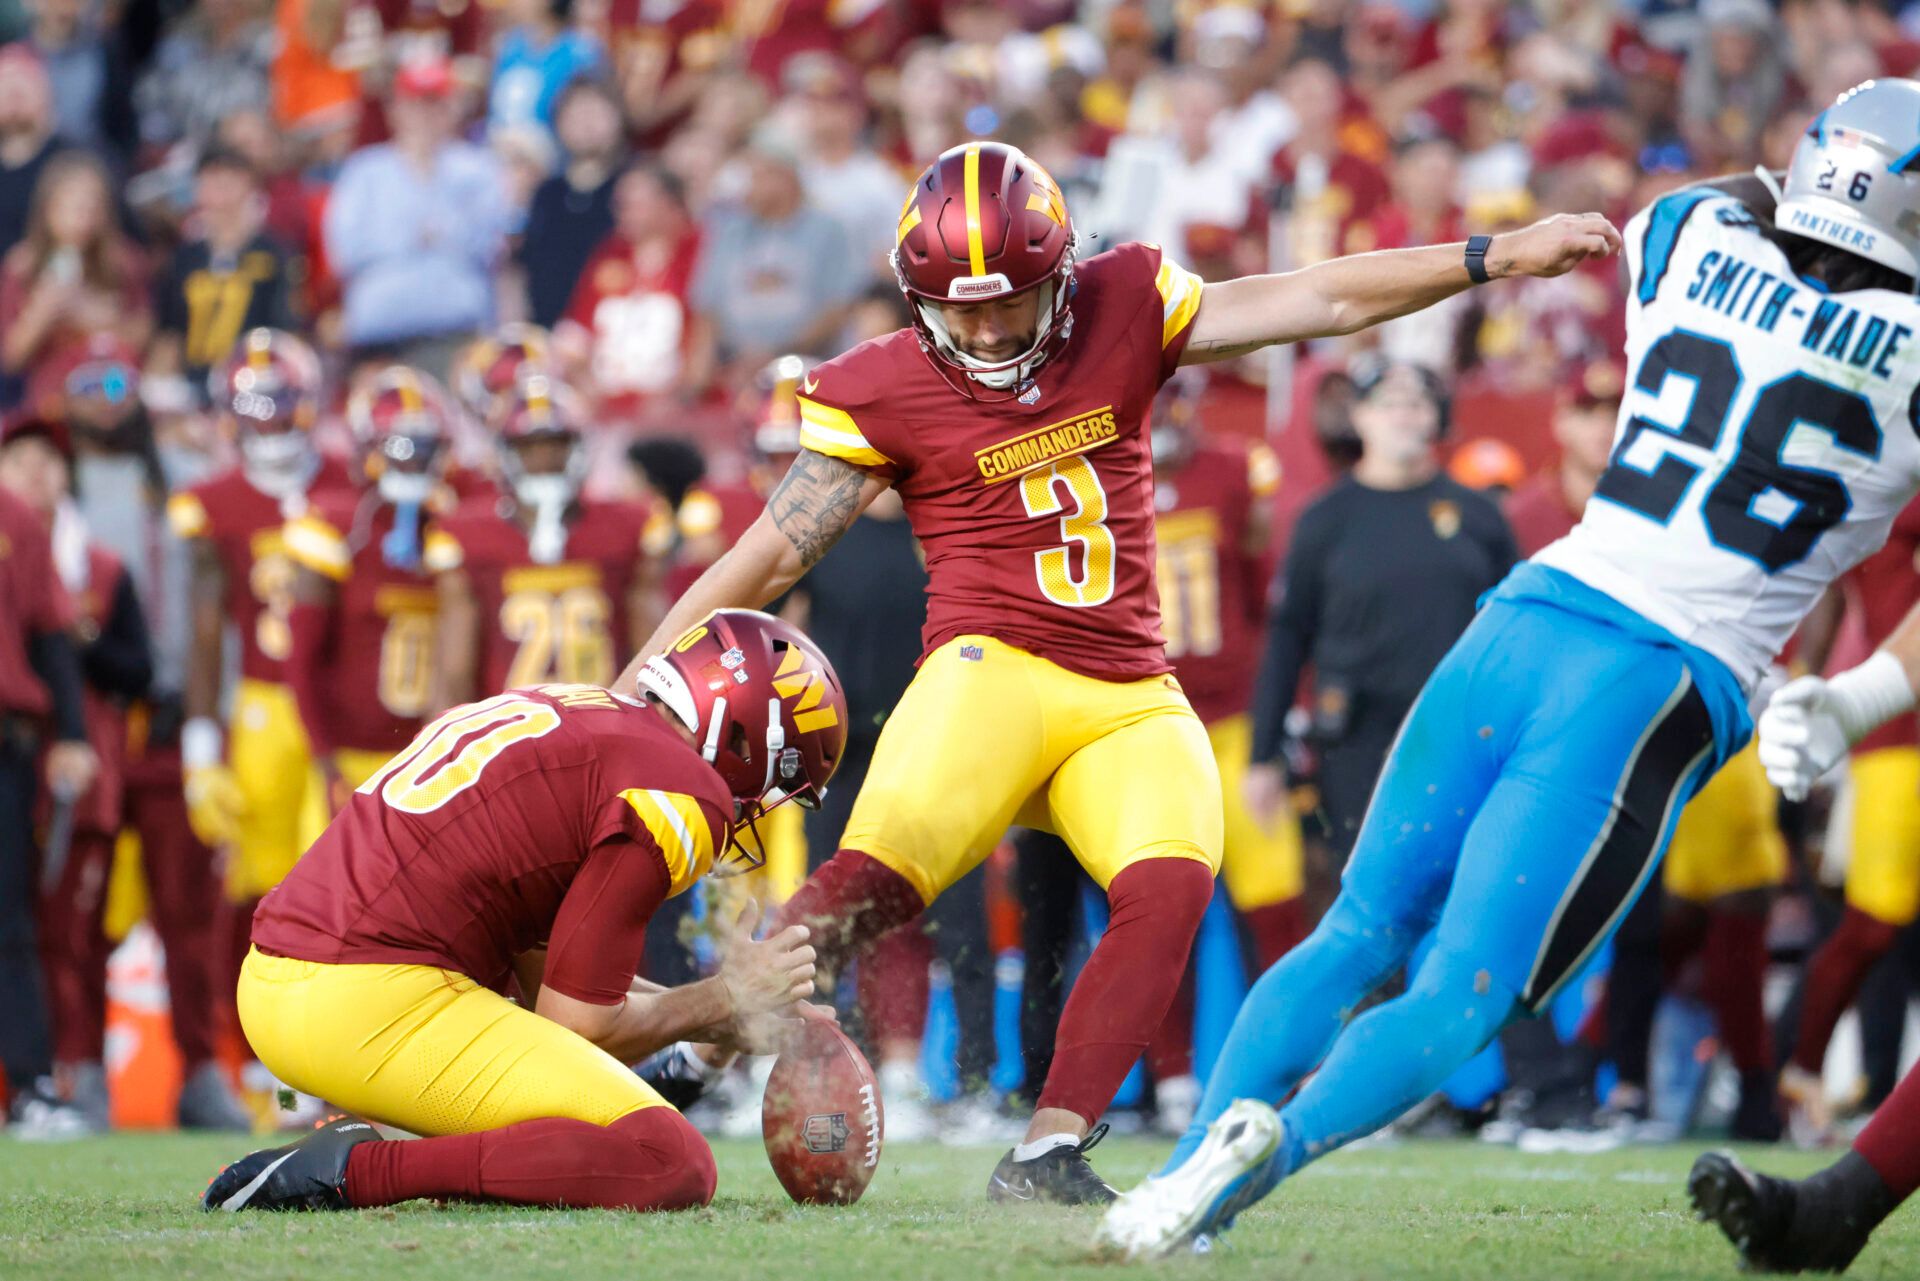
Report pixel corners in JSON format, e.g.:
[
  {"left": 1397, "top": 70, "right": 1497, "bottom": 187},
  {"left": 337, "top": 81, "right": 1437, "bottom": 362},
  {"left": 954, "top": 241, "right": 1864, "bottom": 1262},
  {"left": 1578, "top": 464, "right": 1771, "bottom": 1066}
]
[{"left": 227, "top": 680, "right": 326, "bottom": 903}]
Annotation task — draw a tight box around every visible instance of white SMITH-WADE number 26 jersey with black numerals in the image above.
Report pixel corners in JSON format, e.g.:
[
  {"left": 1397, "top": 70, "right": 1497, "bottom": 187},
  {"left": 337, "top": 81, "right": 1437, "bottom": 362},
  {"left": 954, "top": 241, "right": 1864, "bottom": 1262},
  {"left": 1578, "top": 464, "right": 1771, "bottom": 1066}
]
[{"left": 1534, "top": 190, "right": 1920, "bottom": 689}]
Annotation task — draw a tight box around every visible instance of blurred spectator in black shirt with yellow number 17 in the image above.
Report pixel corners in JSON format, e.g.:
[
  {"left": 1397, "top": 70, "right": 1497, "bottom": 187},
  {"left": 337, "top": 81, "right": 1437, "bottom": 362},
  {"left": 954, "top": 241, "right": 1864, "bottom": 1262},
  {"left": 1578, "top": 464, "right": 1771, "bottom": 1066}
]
[{"left": 148, "top": 148, "right": 296, "bottom": 398}]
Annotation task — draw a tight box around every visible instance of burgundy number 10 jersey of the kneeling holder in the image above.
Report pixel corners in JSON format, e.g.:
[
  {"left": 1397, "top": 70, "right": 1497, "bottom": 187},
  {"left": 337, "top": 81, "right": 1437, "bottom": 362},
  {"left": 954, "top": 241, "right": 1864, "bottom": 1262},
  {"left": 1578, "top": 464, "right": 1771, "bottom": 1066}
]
[{"left": 253, "top": 686, "right": 733, "bottom": 1001}]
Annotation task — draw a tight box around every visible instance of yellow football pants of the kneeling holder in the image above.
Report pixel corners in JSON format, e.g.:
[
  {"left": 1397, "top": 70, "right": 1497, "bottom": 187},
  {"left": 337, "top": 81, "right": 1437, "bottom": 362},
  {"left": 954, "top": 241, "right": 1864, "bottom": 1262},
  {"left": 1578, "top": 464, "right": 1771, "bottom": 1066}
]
[{"left": 238, "top": 949, "right": 668, "bottom": 1135}]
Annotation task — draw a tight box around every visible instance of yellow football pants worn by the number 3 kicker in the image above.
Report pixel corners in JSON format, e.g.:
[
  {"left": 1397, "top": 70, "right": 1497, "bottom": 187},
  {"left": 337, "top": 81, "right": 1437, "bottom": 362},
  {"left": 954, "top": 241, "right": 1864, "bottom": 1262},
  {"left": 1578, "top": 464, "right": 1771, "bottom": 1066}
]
[{"left": 841, "top": 636, "right": 1225, "bottom": 903}]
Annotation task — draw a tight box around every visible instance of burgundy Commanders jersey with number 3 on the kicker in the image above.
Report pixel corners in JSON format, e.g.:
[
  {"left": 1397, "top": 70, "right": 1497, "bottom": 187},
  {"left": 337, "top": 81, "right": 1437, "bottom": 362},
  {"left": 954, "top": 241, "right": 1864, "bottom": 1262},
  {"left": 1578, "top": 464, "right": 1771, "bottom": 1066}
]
[{"left": 799, "top": 244, "right": 1200, "bottom": 680}]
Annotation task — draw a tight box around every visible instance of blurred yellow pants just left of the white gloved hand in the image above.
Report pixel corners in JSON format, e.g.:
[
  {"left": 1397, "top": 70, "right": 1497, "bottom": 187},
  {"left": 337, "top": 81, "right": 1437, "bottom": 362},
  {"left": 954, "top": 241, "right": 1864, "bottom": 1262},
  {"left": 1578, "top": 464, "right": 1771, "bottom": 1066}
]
[{"left": 1663, "top": 743, "right": 1788, "bottom": 903}]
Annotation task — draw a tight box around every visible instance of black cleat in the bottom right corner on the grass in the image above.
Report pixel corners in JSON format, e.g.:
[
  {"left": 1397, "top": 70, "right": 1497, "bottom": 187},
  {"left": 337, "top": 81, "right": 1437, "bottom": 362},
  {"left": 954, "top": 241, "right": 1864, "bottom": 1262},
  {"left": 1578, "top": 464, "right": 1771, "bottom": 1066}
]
[{"left": 1686, "top": 1152, "right": 1878, "bottom": 1273}]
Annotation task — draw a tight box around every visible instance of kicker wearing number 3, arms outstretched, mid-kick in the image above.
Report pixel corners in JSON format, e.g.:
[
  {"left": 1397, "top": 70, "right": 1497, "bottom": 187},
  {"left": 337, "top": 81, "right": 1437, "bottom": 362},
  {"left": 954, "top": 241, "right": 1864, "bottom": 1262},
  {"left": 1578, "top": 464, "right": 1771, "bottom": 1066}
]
[{"left": 620, "top": 142, "right": 1619, "bottom": 1202}]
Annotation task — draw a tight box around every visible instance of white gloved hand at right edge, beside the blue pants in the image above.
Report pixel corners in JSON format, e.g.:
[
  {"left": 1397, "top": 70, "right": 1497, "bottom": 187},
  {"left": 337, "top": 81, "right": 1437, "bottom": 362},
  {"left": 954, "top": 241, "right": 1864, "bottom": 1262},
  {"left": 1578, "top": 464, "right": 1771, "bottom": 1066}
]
[{"left": 1759, "top": 651, "right": 1914, "bottom": 801}]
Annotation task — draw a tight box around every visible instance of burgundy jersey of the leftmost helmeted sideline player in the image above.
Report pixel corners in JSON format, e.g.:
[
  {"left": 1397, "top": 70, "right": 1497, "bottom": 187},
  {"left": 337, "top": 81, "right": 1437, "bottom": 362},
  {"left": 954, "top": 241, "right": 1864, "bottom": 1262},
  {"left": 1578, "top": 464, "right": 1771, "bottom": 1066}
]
[{"left": 167, "top": 457, "right": 353, "bottom": 684}]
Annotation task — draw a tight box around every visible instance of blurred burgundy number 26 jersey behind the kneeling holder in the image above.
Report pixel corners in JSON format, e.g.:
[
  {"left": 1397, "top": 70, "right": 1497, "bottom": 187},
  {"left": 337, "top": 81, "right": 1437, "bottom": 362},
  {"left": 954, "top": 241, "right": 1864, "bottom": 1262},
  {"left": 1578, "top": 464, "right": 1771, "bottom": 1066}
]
[{"left": 426, "top": 499, "right": 653, "bottom": 702}]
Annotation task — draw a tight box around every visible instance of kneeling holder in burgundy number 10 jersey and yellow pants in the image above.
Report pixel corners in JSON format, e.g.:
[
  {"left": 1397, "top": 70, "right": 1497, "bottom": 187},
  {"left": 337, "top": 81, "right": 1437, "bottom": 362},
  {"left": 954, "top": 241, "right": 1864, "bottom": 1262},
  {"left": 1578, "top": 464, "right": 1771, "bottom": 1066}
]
[{"left": 204, "top": 611, "right": 847, "bottom": 1210}]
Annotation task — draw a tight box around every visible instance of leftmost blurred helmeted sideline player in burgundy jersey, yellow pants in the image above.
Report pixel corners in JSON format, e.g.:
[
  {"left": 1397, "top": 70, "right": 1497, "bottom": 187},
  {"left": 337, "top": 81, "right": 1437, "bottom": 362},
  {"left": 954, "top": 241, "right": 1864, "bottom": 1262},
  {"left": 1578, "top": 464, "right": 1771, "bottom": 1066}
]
[{"left": 167, "top": 328, "right": 351, "bottom": 979}]
